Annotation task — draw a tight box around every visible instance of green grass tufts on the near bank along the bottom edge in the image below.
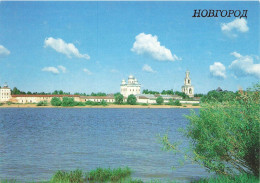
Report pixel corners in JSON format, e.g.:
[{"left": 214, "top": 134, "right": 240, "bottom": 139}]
[{"left": 0, "top": 167, "right": 259, "bottom": 183}]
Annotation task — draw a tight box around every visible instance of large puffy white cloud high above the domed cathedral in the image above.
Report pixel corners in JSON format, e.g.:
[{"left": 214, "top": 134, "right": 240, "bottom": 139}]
[{"left": 131, "top": 33, "right": 181, "bottom": 61}]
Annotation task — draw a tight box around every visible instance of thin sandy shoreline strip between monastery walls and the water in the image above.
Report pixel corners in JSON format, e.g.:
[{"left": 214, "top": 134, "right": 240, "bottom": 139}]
[{"left": 0, "top": 104, "right": 200, "bottom": 109}]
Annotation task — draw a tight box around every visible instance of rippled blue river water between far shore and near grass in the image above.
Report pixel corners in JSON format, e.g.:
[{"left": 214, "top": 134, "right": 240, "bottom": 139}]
[{"left": 0, "top": 108, "right": 208, "bottom": 182}]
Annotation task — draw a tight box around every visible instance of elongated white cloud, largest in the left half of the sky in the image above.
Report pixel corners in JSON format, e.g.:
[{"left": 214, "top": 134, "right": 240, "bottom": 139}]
[{"left": 44, "top": 37, "right": 90, "bottom": 59}]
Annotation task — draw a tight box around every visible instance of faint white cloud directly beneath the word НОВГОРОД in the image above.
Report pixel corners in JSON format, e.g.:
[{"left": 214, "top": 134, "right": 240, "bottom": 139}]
[{"left": 221, "top": 18, "right": 249, "bottom": 37}]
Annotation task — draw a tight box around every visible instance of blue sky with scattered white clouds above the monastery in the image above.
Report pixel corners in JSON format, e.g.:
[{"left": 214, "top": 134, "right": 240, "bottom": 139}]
[{"left": 0, "top": 2, "right": 260, "bottom": 93}]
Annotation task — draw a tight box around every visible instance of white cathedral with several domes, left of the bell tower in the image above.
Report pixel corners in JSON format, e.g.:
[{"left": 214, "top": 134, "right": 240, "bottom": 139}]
[{"left": 120, "top": 75, "right": 141, "bottom": 97}]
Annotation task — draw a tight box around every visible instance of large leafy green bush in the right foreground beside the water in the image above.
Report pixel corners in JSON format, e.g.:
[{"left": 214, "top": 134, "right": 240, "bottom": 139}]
[{"left": 163, "top": 84, "right": 260, "bottom": 176}]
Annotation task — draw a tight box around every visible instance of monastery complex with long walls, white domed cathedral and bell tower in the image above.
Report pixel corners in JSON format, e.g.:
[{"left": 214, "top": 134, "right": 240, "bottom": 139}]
[{"left": 0, "top": 71, "right": 199, "bottom": 104}]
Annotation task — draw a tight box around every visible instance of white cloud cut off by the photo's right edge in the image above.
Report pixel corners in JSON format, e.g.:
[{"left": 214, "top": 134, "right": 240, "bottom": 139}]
[{"left": 229, "top": 52, "right": 260, "bottom": 79}]
